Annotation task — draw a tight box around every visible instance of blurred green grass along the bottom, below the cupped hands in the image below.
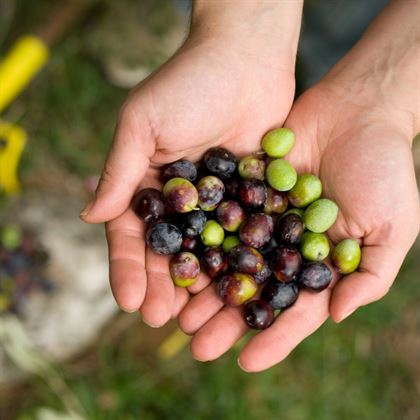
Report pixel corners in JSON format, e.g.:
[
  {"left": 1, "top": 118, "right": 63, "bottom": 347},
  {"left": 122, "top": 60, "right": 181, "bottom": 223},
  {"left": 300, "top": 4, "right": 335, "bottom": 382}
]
[{"left": 7, "top": 252, "right": 420, "bottom": 420}]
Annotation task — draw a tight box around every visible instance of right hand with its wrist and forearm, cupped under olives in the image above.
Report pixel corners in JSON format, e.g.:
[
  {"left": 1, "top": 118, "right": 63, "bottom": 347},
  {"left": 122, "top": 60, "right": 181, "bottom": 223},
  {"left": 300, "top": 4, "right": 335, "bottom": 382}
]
[{"left": 179, "top": 2, "right": 420, "bottom": 372}]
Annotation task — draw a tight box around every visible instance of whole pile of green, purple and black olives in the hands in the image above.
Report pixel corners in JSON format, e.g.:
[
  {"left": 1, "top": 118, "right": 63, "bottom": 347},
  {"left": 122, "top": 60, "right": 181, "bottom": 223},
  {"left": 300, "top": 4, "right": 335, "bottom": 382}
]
[{"left": 132, "top": 128, "right": 361, "bottom": 329}]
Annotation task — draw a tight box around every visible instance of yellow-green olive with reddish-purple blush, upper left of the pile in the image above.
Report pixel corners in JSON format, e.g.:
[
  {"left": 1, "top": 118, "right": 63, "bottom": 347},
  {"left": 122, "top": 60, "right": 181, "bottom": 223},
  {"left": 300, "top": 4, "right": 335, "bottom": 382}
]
[{"left": 163, "top": 178, "right": 198, "bottom": 213}]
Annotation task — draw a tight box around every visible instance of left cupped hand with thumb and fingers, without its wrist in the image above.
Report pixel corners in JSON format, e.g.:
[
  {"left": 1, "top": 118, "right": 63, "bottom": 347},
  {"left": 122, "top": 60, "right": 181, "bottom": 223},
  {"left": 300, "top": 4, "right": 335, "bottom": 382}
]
[{"left": 81, "top": 32, "right": 295, "bottom": 326}]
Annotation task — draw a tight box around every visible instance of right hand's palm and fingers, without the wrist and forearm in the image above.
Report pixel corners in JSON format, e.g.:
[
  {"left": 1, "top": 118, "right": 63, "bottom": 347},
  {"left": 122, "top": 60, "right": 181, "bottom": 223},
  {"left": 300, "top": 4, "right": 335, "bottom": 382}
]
[{"left": 179, "top": 83, "right": 419, "bottom": 371}]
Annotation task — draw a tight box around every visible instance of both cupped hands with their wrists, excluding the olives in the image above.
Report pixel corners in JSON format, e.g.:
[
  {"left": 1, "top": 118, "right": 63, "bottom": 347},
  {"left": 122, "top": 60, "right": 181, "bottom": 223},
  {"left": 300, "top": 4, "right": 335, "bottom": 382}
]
[{"left": 81, "top": 1, "right": 420, "bottom": 372}]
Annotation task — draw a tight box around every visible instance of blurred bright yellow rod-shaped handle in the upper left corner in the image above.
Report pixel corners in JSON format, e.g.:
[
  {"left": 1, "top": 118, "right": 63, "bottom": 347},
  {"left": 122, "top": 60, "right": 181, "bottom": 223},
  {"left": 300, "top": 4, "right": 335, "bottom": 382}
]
[{"left": 0, "top": 35, "right": 49, "bottom": 112}]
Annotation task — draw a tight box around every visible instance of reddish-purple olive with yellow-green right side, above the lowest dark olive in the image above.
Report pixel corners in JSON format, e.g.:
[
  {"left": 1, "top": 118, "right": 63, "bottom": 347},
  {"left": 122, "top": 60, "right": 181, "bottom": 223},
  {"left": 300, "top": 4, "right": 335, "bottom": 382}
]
[{"left": 217, "top": 273, "right": 258, "bottom": 306}]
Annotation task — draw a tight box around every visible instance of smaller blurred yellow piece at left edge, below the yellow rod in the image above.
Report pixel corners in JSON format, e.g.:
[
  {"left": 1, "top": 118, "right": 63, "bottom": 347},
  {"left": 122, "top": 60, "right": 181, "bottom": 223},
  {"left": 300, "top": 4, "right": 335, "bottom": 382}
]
[{"left": 0, "top": 121, "right": 26, "bottom": 194}]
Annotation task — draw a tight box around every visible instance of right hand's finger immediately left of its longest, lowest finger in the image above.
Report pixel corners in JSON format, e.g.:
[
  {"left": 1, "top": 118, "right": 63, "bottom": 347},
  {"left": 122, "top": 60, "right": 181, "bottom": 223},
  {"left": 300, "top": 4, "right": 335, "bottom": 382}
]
[{"left": 191, "top": 306, "right": 249, "bottom": 362}]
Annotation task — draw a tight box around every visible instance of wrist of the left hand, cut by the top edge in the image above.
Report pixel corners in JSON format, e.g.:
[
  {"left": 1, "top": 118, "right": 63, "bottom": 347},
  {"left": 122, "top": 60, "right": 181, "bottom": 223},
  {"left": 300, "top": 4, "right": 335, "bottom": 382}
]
[{"left": 188, "top": 0, "right": 303, "bottom": 70}]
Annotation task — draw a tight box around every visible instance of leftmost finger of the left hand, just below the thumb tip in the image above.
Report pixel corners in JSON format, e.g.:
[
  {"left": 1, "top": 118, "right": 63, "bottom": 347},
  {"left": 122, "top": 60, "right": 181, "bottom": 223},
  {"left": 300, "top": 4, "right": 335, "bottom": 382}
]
[{"left": 106, "top": 209, "right": 146, "bottom": 312}]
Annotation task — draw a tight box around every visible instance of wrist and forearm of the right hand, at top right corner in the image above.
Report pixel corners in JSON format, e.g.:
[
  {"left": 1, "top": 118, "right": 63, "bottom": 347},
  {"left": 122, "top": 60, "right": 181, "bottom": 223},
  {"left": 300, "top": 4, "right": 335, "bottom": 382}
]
[{"left": 324, "top": 1, "right": 420, "bottom": 144}]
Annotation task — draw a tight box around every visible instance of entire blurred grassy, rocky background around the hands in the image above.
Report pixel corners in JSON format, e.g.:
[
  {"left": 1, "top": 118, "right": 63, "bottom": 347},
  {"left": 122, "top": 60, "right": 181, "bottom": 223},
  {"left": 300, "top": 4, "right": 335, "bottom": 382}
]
[{"left": 0, "top": 0, "right": 420, "bottom": 420}]
